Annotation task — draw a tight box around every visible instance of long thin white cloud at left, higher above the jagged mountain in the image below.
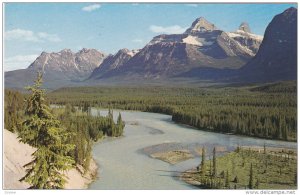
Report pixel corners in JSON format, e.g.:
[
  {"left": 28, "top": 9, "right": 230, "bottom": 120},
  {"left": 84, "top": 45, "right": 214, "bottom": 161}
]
[{"left": 4, "top": 28, "right": 61, "bottom": 42}]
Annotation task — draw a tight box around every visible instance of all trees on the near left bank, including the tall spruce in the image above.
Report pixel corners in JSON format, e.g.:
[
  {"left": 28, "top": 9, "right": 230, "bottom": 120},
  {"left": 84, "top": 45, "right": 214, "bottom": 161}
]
[{"left": 4, "top": 74, "right": 125, "bottom": 189}]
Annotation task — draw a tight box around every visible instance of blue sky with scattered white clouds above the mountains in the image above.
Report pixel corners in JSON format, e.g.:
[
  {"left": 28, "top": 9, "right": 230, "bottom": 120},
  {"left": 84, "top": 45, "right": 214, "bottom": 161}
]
[{"left": 4, "top": 3, "right": 297, "bottom": 71}]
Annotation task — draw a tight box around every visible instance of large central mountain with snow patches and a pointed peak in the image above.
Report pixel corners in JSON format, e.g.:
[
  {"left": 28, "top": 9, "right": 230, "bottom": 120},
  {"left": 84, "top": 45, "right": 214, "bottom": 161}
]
[{"left": 91, "top": 17, "right": 262, "bottom": 79}]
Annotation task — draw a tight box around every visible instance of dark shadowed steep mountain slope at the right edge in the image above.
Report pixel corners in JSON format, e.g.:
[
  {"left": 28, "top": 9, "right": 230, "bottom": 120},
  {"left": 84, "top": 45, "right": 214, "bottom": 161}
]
[{"left": 236, "top": 7, "right": 297, "bottom": 82}]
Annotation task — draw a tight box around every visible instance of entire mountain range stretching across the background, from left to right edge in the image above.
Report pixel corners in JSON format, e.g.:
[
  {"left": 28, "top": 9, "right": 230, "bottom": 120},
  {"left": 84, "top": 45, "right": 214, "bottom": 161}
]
[{"left": 5, "top": 7, "right": 297, "bottom": 89}]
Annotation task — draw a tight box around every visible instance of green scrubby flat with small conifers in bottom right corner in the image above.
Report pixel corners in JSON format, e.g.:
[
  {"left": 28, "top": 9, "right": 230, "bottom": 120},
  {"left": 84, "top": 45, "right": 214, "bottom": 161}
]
[{"left": 191, "top": 148, "right": 297, "bottom": 189}]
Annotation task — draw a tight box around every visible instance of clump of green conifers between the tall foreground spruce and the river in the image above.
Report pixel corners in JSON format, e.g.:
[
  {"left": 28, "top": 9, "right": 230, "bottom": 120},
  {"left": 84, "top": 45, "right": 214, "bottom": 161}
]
[{"left": 53, "top": 104, "right": 125, "bottom": 170}]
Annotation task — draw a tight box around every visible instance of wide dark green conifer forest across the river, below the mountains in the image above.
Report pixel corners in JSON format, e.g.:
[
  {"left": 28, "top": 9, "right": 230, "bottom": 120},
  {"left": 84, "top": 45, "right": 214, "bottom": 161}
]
[{"left": 48, "top": 83, "right": 297, "bottom": 141}]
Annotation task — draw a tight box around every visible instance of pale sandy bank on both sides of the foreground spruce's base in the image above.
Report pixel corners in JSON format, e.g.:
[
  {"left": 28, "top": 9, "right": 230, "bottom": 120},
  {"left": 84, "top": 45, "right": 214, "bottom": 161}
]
[{"left": 3, "top": 129, "right": 98, "bottom": 190}]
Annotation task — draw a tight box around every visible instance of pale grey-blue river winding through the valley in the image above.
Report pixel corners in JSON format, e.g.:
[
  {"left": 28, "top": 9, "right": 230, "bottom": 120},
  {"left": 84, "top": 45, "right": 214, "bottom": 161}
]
[{"left": 89, "top": 109, "right": 297, "bottom": 190}]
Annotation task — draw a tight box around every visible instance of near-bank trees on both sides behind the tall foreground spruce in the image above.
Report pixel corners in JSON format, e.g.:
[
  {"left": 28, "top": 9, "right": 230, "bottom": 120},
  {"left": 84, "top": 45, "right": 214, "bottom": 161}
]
[{"left": 4, "top": 90, "right": 125, "bottom": 175}]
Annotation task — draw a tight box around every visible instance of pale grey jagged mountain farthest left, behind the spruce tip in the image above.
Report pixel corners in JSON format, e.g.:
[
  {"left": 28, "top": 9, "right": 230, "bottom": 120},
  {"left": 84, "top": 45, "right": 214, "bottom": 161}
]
[{"left": 5, "top": 48, "right": 105, "bottom": 89}]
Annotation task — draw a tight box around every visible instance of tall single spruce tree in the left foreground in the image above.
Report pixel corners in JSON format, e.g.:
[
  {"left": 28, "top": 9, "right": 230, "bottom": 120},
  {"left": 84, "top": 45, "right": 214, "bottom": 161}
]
[{"left": 19, "top": 73, "right": 74, "bottom": 189}]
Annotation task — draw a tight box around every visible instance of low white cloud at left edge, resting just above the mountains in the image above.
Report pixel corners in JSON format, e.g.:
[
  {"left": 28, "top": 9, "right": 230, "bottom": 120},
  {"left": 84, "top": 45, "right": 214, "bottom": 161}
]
[{"left": 4, "top": 54, "right": 38, "bottom": 71}]
